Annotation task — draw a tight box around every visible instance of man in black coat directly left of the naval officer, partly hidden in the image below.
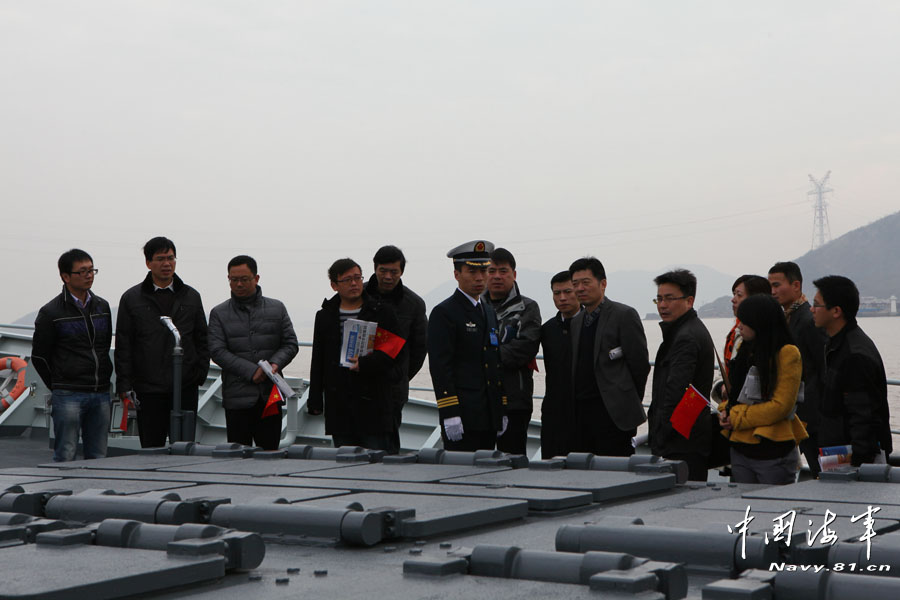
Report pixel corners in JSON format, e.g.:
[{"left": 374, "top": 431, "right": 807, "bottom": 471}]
[{"left": 366, "top": 246, "right": 428, "bottom": 454}]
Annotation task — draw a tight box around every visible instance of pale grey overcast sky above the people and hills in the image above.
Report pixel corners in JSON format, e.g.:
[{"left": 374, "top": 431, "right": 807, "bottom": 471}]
[{"left": 0, "top": 0, "right": 900, "bottom": 322}]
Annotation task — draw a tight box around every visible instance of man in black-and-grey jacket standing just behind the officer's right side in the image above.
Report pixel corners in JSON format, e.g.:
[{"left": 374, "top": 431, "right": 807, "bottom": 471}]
[{"left": 482, "top": 248, "right": 541, "bottom": 454}]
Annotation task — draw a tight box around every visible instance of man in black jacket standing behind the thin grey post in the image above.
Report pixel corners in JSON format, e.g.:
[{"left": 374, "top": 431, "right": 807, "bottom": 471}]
[{"left": 115, "top": 237, "right": 209, "bottom": 448}]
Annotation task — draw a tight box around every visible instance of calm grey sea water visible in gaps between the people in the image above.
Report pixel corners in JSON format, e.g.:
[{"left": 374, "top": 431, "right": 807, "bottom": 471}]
[{"left": 288, "top": 317, "right": 900, "bottom": 429}]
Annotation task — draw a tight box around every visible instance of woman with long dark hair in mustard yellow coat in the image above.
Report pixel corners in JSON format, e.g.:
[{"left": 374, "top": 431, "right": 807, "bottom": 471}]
[{"left": 719, "top": 295, "right": 809, "bottom": 484}]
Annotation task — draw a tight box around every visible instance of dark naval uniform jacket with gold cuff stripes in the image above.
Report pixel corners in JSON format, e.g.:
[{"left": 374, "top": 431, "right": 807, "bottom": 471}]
[{"left": 428, "top": 289, "right": 506, "bottom": 433}]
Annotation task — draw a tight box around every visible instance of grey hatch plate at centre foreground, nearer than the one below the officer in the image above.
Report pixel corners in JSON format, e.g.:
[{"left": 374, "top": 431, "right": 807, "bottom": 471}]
[{"left": 304, "top": 493, "right": 528, "bottom": 538}]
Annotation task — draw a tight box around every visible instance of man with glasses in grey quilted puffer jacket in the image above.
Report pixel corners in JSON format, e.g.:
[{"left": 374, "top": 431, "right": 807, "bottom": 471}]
[{"left": 209, "top": 255, "right": 299, "bottom": 450}]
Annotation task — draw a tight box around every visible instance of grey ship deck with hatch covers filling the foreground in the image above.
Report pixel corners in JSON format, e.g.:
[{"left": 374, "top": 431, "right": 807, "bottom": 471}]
[{"left": 0, "top": 428, "right": 900, "bottom": 600}]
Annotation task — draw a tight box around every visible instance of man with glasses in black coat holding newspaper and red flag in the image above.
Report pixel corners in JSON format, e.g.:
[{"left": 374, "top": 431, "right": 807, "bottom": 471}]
[{"left": 306, "top": 258, "right": 405, "bottom": 452}]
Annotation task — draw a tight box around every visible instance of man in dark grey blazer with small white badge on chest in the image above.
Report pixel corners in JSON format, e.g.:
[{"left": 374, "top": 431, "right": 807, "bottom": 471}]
[{"left": 563, "top": 257, "right": 650, "bottom": 456}]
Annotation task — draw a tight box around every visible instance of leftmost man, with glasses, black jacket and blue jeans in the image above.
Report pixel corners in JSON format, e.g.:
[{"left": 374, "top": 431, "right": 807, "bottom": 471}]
[{"left": 31, "top": 248, "right": 112, "bottom": 462}]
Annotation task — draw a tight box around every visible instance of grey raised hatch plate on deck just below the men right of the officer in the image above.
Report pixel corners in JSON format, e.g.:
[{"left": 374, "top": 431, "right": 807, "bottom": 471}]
[{"left": 444, "top": 469, "right": 675, "bottom": 502}]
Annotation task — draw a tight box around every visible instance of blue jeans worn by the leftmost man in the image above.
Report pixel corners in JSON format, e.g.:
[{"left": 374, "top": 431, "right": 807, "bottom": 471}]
[{"left": 50, "top": 390, "right": 110, "bottom": 462}]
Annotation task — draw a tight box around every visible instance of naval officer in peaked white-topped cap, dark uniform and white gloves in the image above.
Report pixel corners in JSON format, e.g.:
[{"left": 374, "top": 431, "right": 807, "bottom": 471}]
[{"left": 428, "top": 240, "right": 507, "bottom": 451}]
